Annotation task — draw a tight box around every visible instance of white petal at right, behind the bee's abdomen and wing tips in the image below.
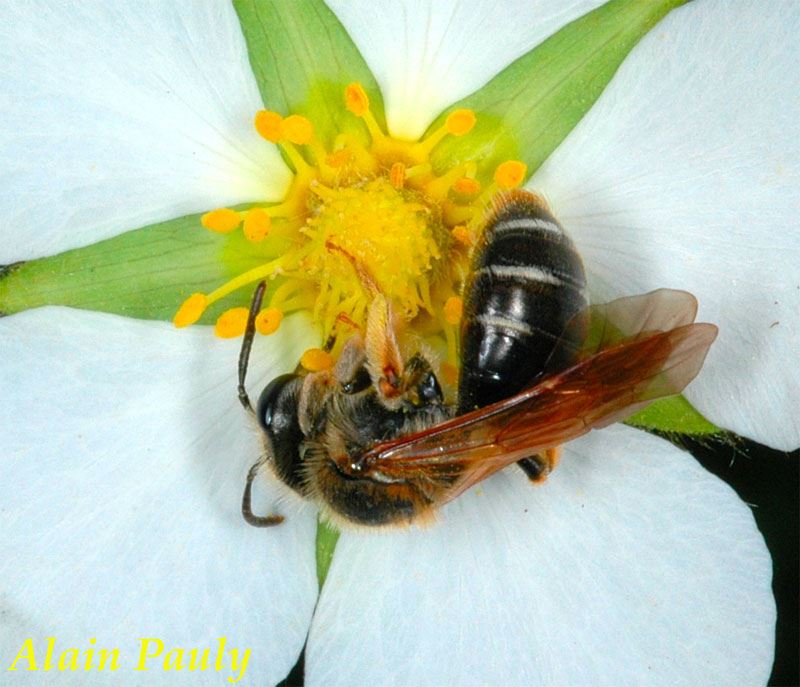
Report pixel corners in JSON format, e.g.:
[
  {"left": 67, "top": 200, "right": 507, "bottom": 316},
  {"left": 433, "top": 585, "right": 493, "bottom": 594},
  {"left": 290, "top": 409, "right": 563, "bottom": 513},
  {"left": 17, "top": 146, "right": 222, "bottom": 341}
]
[{"left": 531, "top": 0, "right": 800, "bottom": 450}]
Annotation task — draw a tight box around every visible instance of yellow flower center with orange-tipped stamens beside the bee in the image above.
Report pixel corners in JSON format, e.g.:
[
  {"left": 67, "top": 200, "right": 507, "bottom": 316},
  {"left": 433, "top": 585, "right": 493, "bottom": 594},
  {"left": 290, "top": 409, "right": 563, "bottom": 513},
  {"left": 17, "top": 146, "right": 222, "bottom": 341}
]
[{"left": 174, "top": 83, "right": 525, "bottom": 369}]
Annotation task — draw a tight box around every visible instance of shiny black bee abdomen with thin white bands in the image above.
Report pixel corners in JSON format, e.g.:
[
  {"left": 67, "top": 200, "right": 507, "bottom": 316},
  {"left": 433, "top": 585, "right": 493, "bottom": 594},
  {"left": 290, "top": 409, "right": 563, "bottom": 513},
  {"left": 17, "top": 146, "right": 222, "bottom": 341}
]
[{"left": 458, "top": 191, "right": 587, "bottom": 414}]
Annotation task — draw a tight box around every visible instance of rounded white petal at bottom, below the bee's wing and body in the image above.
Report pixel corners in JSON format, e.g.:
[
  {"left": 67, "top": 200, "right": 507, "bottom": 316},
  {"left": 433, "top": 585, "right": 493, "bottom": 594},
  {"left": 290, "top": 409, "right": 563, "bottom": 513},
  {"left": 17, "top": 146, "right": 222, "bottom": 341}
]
[{"left": 306, "top": 425, "right": 775, "bottom": 687}]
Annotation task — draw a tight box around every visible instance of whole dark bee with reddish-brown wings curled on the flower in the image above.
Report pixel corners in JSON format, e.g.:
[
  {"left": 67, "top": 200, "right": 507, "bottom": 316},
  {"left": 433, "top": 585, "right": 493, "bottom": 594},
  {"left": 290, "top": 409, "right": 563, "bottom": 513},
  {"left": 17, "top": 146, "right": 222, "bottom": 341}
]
[{"left": 238, "top": 191, "right": 717, "bottom": 527}]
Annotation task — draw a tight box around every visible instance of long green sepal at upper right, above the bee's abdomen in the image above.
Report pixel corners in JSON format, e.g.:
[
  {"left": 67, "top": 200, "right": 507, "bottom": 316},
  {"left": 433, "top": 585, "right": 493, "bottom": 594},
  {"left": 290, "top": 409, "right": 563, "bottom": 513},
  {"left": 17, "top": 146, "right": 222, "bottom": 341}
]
[{"left": 430, "top": 0, "right": 686, "bottom": 179}]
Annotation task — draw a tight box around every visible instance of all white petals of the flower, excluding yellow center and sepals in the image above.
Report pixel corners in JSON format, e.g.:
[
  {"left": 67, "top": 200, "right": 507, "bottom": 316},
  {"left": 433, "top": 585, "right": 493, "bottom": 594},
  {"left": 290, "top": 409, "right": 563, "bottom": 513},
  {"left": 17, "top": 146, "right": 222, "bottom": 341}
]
[{"left": 0, "top": 0, "right": 800, "bottom": 685}]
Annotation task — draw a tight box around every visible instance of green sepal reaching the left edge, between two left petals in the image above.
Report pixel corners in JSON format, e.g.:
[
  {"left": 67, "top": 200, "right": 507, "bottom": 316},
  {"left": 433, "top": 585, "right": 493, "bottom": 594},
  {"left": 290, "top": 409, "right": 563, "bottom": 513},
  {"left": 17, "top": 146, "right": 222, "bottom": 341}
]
[{"left": 0, "top": 211, "right": 286, "bottom": 323}]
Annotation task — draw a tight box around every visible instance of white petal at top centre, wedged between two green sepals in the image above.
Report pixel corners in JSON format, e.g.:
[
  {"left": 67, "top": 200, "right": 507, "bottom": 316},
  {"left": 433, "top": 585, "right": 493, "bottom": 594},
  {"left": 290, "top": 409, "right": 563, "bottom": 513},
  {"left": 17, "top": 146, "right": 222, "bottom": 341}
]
[{"left": 328, "top": 0, "right": 603, "bottom": 138}]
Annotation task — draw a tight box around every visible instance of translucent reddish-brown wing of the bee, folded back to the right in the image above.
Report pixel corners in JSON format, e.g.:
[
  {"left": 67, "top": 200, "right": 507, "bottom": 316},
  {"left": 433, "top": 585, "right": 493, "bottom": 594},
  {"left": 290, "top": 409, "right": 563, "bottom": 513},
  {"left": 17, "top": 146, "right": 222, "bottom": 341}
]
[{"left": 362, "top": 290, "right": 717, "bottom": 501}]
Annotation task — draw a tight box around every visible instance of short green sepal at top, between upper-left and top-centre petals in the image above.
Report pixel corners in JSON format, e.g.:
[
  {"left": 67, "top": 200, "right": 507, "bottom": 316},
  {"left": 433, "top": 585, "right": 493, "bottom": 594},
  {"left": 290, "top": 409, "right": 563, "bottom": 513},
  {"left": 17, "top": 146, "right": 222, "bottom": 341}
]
[{"left": 233, "top": 0, "right": 384, "bottom": 149}]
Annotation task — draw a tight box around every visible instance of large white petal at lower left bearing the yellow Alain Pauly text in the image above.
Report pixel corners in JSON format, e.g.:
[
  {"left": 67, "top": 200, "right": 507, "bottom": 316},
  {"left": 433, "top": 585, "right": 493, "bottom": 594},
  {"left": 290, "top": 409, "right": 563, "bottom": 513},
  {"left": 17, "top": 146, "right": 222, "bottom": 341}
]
[{"left": 0, "top": 308, "right": 317, "bottom": 685}]
